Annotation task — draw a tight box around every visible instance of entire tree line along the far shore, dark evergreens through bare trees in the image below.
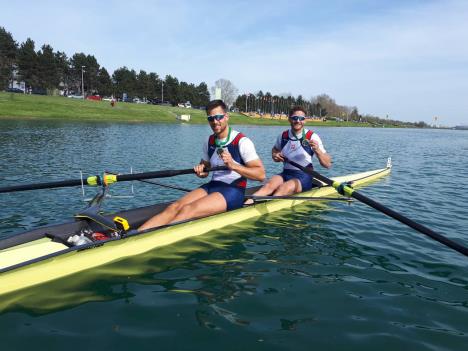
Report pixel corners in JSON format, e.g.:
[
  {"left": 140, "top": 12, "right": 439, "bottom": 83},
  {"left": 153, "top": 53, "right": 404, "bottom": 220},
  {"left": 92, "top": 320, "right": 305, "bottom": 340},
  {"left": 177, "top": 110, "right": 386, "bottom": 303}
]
[{"left": 0, "top": 27, "right": 428, "bottom": 127}]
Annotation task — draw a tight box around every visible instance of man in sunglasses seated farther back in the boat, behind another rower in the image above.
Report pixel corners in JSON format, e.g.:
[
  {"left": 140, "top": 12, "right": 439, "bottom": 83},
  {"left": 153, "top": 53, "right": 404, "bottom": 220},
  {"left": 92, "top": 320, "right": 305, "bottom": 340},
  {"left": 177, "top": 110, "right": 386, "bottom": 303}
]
[{"left": 245, "top": 106, "right": 331, "bottom": 205}]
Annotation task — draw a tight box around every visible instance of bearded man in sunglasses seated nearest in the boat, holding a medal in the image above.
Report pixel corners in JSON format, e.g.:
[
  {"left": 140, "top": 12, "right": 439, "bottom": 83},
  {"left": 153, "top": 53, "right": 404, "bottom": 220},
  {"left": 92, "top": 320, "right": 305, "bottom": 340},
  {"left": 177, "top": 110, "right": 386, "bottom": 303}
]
[{"left": 138, "top": 100, "right": 265, "bottom": 230}]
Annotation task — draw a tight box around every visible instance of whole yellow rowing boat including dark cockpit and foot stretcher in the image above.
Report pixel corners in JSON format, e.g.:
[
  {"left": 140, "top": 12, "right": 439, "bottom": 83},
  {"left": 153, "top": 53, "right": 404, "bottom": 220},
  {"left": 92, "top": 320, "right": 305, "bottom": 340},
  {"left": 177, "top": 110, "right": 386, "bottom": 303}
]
[{"left": 0, "top": 165, "right": 391, "bottom": 295}]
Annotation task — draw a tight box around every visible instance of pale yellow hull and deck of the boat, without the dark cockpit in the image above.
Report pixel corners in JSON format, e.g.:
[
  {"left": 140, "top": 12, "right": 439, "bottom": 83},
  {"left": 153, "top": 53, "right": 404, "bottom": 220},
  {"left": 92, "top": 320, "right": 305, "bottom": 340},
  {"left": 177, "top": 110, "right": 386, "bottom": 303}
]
[{"left": 0, "top": 168, "right": 390, "bottom": 295}]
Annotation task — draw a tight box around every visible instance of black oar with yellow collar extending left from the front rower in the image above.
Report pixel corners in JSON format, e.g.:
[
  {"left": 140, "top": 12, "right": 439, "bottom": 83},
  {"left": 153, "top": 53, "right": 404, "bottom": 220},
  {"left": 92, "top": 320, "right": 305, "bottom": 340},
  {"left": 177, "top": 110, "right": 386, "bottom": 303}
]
[{"left": 0, "top": 166, "right": 227, "bottom": 193}]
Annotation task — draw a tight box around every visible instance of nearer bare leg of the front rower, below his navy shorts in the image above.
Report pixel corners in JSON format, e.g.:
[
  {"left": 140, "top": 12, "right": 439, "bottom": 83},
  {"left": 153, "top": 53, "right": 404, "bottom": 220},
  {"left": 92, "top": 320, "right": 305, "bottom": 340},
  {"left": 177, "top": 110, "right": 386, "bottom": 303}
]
[{"left": 171, "top": 192, "right": 227, "bottom": 223}]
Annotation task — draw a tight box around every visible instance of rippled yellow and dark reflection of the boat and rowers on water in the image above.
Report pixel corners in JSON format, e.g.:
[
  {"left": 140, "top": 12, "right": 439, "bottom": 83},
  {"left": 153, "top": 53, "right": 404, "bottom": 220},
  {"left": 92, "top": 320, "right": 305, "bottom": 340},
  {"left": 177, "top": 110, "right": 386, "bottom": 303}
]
[{"left": 0, "top": 202, "right": 336, "bottom": 316}]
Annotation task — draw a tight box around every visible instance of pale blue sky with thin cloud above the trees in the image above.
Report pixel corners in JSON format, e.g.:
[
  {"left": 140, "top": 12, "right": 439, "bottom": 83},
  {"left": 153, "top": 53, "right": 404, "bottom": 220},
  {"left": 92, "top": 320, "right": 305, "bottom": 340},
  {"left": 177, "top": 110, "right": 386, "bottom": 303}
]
[{"left": 0, "top": 0, "right": 468, "bottom": 126}]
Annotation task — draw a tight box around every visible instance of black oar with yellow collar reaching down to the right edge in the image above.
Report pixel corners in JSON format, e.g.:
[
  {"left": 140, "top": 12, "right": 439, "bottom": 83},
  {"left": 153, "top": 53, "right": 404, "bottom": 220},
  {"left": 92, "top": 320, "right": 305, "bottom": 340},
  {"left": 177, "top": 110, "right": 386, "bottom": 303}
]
[{"left": 285, "top": 158, "right": 468, "bottom": 256}]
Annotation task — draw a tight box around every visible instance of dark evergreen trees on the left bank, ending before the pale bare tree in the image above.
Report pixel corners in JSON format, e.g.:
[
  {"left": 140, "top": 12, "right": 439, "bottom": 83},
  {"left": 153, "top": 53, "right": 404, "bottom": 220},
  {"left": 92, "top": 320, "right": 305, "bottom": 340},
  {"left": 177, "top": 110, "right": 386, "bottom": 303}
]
[{"left": 0, "top": 27, "right": 210, "bottom": 106}]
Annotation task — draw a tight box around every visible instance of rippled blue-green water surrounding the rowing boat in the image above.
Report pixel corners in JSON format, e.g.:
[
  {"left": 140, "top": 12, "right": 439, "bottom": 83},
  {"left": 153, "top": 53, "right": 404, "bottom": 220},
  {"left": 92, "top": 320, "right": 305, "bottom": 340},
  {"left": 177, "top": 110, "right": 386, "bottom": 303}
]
[{"left": 0, "top": 121, "right": 468, "bottom": 350}]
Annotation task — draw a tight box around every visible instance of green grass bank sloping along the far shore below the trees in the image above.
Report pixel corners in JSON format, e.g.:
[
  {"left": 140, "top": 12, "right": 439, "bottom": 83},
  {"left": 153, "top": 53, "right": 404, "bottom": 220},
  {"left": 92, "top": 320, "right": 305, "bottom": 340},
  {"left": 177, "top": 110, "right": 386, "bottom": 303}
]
[{"left": 0, "top": 92, "right": 371, "bottom": 127}]
